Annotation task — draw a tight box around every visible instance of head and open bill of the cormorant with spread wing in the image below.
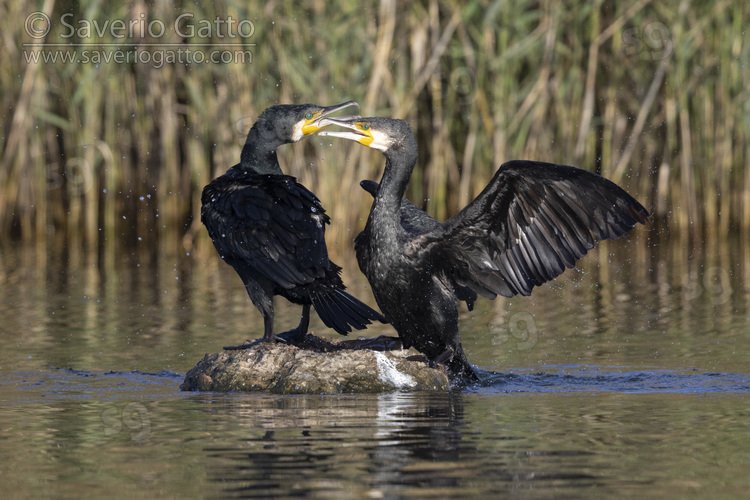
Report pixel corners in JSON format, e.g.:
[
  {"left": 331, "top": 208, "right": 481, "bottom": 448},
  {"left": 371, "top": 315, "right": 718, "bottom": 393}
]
[{"left": 319, "top": 117, "right": 417, "bottom": 159}]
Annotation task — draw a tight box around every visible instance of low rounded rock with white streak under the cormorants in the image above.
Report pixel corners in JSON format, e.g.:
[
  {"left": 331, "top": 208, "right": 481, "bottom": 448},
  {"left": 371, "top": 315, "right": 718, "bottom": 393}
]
[{"left": 180, "top": 335, "right": 450, "bottom": 394}]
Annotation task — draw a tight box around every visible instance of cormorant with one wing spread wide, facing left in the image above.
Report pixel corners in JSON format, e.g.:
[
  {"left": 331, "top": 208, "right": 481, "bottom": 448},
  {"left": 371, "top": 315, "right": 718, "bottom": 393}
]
[{"left": 321, "top": 117, "right": 648, "bottom": 379}]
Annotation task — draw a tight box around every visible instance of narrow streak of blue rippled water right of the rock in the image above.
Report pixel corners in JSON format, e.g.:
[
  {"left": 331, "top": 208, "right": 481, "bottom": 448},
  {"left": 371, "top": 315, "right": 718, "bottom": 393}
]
[{"left": 464, "top": 365, "right": 750, "bottom": 394}]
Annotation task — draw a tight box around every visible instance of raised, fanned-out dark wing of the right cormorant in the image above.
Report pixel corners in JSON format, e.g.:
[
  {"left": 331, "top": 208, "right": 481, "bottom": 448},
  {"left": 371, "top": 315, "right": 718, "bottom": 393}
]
[{"left": 420, "top": 161, "right": 648, "bottom": 298}]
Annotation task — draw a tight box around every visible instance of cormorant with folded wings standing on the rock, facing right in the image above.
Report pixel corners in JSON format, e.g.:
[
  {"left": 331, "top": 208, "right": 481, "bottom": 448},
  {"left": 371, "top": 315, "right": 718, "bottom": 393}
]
[{"left": 201, "top": 101, "right": 384, "bottom": 348}]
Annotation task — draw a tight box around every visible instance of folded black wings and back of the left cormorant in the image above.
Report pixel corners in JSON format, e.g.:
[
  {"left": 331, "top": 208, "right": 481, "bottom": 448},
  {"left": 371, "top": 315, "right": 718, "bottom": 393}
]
[{"left": 201, "top": 170, "right": 331, "bottom": 288}]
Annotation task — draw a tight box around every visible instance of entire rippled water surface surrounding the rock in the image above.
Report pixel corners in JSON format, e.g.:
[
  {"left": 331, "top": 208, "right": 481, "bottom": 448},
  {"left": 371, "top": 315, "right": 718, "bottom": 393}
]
[{"left": 0, "top": 229, "right": 750, "bottom": 498}]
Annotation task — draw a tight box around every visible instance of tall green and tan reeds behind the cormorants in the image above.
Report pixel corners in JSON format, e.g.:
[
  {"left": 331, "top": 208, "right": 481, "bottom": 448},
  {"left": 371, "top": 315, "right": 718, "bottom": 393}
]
[{"left": 0, "top": 0, "right": 750, "bottom": 253}]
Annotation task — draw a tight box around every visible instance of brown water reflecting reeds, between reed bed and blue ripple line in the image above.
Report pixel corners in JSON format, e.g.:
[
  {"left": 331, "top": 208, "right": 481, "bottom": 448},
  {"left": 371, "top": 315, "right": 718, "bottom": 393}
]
[{"left": 0, "top": 217, "right": 750, "bottom": 372}]
